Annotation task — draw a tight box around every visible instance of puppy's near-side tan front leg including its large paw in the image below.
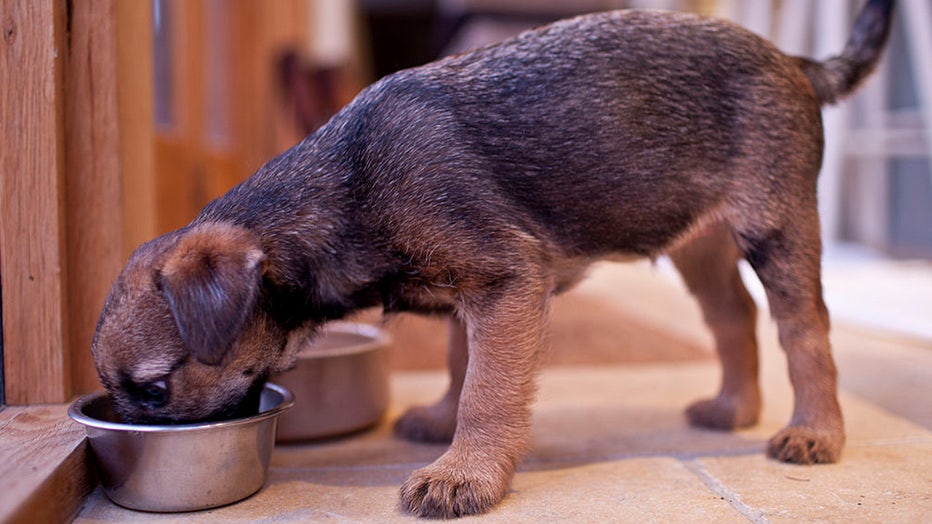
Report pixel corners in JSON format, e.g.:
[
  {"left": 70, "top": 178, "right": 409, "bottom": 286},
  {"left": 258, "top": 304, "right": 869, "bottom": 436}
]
[{"left": 401, "top": 285, "right": 549, "bottom": 518}]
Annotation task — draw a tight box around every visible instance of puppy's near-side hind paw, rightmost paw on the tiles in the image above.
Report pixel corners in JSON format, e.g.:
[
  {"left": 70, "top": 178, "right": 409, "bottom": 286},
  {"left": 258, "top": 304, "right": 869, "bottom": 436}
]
[{"left": 767, "top": 426, "right": 845, "bottom": 464}]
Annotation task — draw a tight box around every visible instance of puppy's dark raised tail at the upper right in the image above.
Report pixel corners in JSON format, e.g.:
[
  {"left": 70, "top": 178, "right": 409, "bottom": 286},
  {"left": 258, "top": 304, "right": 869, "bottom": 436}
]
[{"left": 799, "top": 0, "right": 896, "bottom": 104}]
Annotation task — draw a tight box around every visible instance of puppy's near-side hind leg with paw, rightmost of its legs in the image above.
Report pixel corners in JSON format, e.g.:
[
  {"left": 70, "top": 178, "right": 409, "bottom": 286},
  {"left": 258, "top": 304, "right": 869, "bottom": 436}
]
[{"left": 741, "top": 219, "right": 845, "bottom": 464}]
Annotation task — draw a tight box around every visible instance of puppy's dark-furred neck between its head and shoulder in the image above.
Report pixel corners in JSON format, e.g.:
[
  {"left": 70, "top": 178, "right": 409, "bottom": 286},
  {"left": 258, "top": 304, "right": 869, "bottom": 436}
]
[{"left": 192, "top": 135, "right": 386, "bottom": 328}]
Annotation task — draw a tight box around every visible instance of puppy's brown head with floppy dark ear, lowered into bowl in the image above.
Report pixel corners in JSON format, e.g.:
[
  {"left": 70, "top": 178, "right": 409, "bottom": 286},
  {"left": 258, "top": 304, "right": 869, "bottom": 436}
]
[{"left": 92, "top": 223, "right": 290, "bottom": 423}]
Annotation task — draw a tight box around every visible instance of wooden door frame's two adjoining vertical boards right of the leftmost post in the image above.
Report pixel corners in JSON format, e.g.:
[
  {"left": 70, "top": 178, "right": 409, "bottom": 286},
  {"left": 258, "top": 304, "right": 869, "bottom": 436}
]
[{"left": 64, "top": 0, "right": 155, "bottom": 395}]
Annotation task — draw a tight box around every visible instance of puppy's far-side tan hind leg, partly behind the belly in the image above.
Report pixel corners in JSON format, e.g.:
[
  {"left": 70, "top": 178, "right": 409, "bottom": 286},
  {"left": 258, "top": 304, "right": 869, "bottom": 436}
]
[{"left": 670, "top": 224, "right": 761, "bottom": 429}]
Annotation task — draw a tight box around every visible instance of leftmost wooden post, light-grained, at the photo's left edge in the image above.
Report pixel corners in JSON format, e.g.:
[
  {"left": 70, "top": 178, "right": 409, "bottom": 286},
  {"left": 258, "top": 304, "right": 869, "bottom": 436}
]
[{"left": 0, "top": 0, "right": 71, "bottom": 404}]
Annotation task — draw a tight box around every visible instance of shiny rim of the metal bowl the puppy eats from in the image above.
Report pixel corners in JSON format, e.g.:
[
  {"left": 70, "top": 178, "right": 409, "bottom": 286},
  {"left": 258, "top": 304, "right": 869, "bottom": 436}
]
[{"left": 68, "top": 382, "right": 294, "bottom": 433}]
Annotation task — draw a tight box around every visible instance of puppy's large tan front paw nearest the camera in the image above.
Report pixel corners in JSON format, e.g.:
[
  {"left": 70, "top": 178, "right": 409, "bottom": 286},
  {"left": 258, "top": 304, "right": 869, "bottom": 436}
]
[{"left": 401, "top": 453, "right": 510, "bottom": 519}]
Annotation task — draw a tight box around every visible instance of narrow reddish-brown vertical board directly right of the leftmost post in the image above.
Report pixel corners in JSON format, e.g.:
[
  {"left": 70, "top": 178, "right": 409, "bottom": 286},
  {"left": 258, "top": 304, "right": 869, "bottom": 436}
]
[{"left": 60, "top": 0, "right": 122, "bottom": 401}]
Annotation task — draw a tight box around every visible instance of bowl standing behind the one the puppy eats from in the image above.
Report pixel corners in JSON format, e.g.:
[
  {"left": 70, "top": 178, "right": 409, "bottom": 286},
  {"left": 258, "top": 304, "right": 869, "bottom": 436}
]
[{"left": 274, "top": 322, "right": 390, "bottom": 442}]
